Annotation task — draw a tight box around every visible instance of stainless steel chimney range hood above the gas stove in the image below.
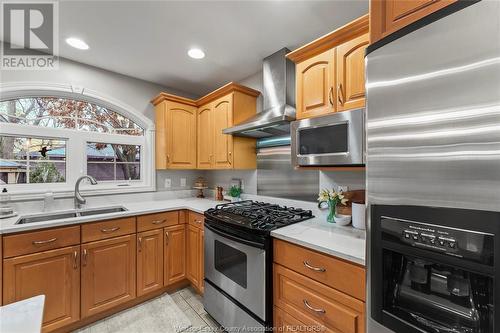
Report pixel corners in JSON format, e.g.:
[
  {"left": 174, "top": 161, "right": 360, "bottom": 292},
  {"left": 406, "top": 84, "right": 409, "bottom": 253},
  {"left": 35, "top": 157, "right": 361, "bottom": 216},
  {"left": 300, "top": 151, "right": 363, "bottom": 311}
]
[{"left": 222, "top": 48, "right": 295, "bottom": 138}]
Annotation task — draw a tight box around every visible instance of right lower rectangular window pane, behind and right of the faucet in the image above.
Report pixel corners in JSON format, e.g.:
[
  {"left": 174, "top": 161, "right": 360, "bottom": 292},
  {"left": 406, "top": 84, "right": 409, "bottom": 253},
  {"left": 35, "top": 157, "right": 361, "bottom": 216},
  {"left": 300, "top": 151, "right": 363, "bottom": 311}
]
[{"left": 86, "top": 142, "right": 141, "bottom": 181}]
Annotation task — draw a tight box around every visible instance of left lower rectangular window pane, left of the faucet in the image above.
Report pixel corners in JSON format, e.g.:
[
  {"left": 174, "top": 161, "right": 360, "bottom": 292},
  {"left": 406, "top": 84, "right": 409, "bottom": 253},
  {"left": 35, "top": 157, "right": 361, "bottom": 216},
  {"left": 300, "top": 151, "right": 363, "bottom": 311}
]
[{"left": 0, "top": 136, "right": 66, "bottom": 184}]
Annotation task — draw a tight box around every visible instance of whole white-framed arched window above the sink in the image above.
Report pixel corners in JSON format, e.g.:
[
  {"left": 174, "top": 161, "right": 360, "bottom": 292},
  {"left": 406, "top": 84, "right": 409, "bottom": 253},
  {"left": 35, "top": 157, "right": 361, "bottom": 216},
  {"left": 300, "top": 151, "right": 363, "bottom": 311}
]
[{"left": 0, "top": 94, "right": 154, "bottom": 193}]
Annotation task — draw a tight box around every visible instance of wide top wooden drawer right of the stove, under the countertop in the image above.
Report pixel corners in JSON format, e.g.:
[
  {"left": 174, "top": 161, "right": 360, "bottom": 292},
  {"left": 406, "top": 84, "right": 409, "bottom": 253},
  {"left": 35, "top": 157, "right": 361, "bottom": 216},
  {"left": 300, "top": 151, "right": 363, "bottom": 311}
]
[{"left": 274, "top": 240, "right": 366, "bottom": 301}]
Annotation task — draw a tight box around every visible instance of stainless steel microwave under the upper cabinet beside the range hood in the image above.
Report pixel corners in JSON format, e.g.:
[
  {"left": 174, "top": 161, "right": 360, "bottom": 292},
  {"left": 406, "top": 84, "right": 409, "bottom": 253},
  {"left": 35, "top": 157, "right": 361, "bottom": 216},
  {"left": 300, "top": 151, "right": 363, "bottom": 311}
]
[{"left": 291, "top": 109, "right": 365, "bottom": 166}]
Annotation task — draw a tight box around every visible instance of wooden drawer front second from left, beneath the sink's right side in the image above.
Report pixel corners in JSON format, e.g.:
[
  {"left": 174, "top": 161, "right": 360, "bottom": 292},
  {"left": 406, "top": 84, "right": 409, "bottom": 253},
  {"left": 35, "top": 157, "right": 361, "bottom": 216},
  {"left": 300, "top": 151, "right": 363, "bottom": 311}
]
[{"left": 82, "top": 217, "right": 135, "bottom": 243}]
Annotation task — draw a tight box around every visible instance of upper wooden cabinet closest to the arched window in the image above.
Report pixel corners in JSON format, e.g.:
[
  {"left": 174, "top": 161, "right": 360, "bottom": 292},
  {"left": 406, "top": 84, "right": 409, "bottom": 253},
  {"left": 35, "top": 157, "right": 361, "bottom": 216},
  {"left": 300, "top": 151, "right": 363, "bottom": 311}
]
[{"left": 155, "top": 94, "right": 197, "bottom": 169}]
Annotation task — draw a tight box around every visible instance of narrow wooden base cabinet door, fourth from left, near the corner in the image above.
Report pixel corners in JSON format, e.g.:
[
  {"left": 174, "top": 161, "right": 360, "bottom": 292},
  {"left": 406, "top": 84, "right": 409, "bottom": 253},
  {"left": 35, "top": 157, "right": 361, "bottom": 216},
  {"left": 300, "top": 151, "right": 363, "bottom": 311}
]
[{"left": 164, "top": 224, "right": 186, "bottom": 286}]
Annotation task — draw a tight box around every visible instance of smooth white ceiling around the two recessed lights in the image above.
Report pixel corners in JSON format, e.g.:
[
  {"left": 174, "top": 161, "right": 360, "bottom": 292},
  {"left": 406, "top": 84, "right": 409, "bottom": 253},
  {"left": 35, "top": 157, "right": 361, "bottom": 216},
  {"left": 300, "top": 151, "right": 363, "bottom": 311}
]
[{"left": 59, "top": 0, "right": 368, "bottom": 95}]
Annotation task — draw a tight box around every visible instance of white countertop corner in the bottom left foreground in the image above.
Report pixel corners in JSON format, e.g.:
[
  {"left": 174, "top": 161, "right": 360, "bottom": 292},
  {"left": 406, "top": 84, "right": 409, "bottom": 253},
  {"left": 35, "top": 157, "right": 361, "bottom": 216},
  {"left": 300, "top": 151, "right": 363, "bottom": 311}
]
[{"left": 0, "top": 295, "right": 45, "bottom": 333}]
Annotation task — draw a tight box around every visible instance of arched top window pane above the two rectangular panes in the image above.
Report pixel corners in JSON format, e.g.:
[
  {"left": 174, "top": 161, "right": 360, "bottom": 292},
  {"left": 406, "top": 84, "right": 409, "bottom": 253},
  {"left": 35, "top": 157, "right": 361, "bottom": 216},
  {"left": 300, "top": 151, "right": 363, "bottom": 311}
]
[{"left": 0, "top": 96, "right": 144, "bottom": 136}]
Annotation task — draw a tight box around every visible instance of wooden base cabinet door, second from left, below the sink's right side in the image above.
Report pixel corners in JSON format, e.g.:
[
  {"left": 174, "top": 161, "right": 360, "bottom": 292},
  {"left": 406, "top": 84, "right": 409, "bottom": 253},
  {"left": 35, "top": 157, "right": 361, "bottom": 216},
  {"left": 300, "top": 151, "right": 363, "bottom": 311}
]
[{"left": 82, "top": 235, "right": 136, "bottom": 317}]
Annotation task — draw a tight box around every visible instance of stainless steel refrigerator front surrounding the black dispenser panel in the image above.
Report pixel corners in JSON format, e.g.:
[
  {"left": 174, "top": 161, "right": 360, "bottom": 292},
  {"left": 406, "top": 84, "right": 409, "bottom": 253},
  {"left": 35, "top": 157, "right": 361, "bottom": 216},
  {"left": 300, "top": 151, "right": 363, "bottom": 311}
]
[{"left": 366, "top": 0, "right": 500, "bottom": 333}]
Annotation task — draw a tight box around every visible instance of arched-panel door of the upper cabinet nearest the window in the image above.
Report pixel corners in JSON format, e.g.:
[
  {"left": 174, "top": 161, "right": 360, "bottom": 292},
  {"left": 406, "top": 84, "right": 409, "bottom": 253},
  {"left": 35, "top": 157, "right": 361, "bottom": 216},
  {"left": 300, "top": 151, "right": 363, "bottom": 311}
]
[{"left": 167, "top": 102, "right": 196, "bottom": 169}]
